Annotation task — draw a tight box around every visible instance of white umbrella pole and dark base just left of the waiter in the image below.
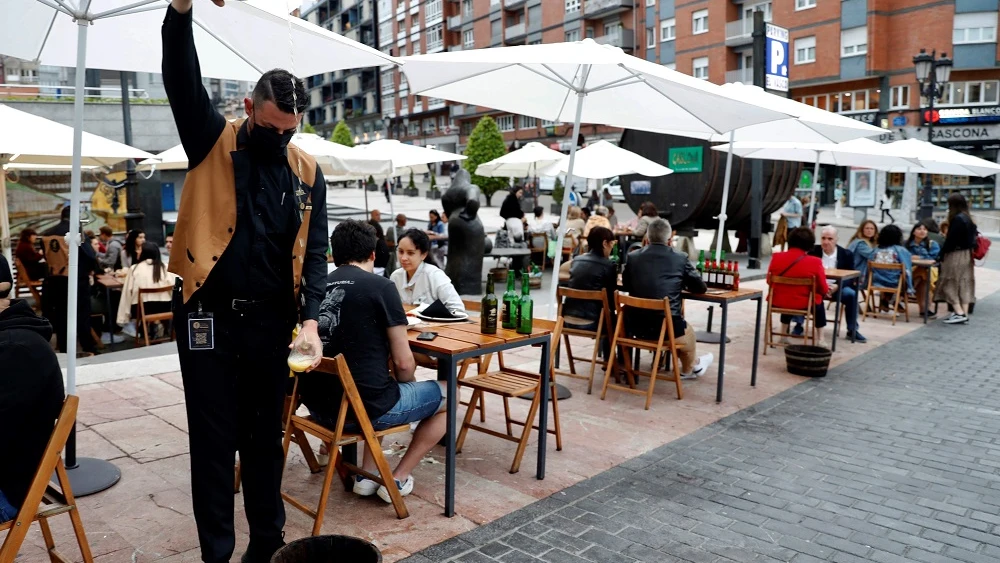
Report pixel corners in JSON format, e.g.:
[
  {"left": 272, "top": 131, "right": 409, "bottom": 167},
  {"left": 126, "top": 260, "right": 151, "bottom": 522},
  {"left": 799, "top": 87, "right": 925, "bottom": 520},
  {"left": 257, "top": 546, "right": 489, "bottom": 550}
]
[{"left": 66, "top": 19, "right": 122, "bottom": 497}]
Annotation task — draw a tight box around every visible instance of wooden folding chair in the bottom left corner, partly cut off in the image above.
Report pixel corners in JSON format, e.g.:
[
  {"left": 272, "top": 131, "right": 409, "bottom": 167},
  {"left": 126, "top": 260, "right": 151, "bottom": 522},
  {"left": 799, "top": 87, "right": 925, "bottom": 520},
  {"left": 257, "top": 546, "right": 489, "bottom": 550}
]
[{"left": 0, "top": 395, "right": 94, "bottom": 563}]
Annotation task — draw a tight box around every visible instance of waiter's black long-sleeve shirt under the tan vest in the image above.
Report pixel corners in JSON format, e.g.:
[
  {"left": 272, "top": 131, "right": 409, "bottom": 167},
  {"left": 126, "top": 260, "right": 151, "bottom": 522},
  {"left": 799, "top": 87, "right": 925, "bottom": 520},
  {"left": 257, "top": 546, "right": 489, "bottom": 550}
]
[{"left": 163, "top": 6, "right": 327, "bottom": 320}]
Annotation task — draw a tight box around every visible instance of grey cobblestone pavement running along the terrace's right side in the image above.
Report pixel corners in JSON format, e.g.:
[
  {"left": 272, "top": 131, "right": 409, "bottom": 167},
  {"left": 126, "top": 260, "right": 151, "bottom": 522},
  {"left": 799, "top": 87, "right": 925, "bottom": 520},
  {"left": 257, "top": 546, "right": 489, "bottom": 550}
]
[{"left": 404, "top": 296, "right": 1000, "bottom": 563}]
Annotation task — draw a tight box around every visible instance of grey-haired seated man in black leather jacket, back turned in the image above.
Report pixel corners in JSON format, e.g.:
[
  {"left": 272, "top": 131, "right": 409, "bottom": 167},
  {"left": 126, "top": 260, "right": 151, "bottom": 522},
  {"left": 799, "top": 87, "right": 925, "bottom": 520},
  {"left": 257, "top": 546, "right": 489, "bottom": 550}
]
[{"left": 622, "top": 218, "right": 714, "bottom": 379}]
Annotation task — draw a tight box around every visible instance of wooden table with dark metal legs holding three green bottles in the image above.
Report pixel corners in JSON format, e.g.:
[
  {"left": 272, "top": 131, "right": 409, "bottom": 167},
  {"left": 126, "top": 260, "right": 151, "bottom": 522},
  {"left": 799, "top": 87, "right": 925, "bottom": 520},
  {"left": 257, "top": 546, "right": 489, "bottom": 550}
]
[{"left": 407, "top": 320, "right": 555, "bottom": 517}]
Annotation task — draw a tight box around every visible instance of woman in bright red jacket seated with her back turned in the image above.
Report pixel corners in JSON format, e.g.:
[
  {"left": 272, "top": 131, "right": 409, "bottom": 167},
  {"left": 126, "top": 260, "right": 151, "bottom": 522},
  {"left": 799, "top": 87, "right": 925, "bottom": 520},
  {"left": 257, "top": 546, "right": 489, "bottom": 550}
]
[{"left": 767, "top": 227, "right": 830, "bottom": 345}]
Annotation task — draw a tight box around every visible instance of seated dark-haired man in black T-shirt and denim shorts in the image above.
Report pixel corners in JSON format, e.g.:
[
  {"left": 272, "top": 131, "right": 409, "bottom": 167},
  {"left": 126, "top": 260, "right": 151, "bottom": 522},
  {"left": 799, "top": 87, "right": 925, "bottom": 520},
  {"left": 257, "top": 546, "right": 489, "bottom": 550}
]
[{"left": 301, "top": 220, "right": 447, "bottom": 502}]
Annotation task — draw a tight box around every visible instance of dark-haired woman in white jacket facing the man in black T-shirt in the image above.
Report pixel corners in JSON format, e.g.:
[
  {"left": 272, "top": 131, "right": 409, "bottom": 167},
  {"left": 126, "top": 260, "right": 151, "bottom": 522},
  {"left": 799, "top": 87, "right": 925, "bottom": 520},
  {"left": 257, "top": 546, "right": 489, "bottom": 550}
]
[{"left": 389, "top": 229, "right": 465, "bottom": 314}]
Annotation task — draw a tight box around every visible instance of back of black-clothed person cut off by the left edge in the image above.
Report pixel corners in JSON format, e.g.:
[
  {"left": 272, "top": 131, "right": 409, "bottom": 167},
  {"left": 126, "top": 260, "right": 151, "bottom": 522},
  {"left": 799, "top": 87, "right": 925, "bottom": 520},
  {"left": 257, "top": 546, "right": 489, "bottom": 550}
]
[{"left": 0, "top": 299, "right": 64, "bottom": 522}]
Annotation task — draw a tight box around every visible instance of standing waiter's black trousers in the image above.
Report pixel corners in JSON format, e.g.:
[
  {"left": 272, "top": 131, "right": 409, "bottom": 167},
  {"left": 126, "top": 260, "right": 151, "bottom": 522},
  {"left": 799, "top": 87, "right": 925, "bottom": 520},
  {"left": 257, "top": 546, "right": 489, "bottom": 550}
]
[{"left": 174, "top": 290, "right": 294, "bottom": 563}]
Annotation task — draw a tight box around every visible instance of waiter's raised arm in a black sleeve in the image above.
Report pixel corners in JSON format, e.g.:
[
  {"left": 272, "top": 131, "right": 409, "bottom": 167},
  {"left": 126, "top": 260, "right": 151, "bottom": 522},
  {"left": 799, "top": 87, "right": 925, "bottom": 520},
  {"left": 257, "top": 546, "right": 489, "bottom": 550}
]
[{"left": 161, "top": 0, "right": 226, "bottom": 168}]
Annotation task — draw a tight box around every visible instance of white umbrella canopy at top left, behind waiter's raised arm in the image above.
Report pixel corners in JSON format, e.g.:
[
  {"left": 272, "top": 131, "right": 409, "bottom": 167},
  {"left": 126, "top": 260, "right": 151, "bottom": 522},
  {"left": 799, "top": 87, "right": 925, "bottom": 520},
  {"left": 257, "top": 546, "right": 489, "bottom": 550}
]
[{"left": 0, "top": 0, "right": 394, "bottom": 82}]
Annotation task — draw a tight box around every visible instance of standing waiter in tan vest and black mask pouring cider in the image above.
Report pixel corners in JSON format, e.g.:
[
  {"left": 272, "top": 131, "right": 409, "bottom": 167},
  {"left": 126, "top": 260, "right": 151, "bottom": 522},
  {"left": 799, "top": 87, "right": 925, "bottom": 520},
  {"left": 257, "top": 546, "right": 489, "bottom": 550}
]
[{"left": 162, "top": 0, "right": 327, "bottom": 563}]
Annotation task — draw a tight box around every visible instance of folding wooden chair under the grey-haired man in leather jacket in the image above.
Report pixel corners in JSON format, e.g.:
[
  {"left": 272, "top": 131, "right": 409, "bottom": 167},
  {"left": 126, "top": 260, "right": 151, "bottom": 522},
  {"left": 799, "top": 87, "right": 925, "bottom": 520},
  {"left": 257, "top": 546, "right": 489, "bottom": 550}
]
[{"left": 601, "top": 291, "right": 684, "bottom": 410}]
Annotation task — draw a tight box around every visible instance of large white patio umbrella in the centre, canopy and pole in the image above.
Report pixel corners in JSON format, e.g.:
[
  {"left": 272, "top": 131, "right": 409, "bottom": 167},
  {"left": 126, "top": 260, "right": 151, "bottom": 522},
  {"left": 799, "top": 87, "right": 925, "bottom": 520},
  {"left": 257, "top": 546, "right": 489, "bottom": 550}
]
[{"left": 402, "top": 39, "right": 788, "bottom": 304}]
